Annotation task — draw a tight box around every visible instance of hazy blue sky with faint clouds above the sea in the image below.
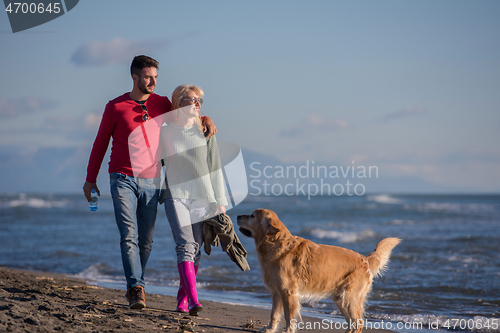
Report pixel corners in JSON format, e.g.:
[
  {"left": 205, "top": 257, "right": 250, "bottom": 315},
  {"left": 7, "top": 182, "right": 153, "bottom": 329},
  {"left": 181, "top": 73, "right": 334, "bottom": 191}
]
[{"left": 0, "top": 0, "right": 500, "bottom": 193}]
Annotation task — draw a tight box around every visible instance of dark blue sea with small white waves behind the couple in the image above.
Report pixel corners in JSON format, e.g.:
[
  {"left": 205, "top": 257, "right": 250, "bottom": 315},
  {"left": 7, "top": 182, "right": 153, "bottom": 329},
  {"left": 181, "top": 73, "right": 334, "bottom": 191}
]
[{"left": 0, "top": 193, "right": 500, "bottom": 332}]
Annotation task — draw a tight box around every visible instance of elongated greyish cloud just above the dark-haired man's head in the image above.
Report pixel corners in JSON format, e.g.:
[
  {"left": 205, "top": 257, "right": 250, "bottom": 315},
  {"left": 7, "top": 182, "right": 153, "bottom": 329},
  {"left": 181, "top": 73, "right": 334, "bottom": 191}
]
[{"left": 71, "top": 37, "right": 167, "bottom": 67}]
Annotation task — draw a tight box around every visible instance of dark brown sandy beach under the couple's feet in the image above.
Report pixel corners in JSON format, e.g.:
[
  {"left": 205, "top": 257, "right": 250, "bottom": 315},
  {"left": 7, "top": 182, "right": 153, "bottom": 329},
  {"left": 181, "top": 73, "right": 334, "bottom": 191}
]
[{"left": 0, "top": 267, "right": 396, "bottom": 333}]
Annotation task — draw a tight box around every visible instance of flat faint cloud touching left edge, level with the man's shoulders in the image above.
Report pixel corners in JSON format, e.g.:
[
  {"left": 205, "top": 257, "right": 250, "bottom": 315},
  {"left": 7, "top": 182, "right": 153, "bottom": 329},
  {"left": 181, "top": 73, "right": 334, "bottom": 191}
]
[{"left": 0, "top": 97, "right": 57, "bottom": 118}]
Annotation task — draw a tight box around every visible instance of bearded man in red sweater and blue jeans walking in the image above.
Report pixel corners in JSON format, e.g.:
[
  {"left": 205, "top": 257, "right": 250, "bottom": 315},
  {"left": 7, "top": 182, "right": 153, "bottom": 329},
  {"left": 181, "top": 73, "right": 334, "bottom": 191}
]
[{"left": 83, "top": 55, "right": 217, "bottom": 309}]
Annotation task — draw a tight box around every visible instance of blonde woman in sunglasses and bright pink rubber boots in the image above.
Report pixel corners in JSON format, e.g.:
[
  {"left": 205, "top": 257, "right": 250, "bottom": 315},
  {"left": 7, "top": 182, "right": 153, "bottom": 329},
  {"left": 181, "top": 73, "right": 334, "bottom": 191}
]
[{"left": 162, "top": 85, "right": 227, "bottom": 316}]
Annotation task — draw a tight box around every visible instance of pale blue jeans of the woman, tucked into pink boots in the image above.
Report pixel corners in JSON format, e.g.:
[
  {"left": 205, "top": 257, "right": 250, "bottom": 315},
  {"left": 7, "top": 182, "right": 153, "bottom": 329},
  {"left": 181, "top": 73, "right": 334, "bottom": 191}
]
[{"left": 165, "top": 199, "right": 210, "bottom": 266}]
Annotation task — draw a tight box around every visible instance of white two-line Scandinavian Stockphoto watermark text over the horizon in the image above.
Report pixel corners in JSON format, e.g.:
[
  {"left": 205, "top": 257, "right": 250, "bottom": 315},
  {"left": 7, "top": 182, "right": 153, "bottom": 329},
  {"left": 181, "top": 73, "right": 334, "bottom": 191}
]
[{"left": 248, "top": 160, "right": 379, "bottom": 200}]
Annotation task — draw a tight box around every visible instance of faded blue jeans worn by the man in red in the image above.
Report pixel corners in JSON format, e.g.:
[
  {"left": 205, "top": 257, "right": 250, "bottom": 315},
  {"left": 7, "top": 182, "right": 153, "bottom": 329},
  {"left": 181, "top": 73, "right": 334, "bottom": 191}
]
[{"left": 109, "top": 173, "right": 160, "bottom": 288}]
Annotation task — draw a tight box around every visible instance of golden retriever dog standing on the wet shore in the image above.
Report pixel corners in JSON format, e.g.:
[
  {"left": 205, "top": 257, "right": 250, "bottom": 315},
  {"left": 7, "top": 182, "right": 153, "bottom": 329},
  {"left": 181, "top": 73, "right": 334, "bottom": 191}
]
[{"left": 238, "top": 209, "right": 401, "bottom": 333}]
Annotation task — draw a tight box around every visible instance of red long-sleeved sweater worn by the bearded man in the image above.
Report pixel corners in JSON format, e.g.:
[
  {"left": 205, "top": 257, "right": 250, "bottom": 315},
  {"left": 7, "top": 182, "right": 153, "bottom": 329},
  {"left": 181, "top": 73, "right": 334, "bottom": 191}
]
[{"left": 86, "top": 93, "right": 172, "bottom": 183}]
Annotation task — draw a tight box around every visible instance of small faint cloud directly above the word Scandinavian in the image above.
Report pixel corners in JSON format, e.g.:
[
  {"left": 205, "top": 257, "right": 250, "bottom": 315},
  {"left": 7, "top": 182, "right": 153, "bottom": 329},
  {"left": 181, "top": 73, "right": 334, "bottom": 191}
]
[{"left": 279, "top": 113, "right": 349, "bottom": 137}]
